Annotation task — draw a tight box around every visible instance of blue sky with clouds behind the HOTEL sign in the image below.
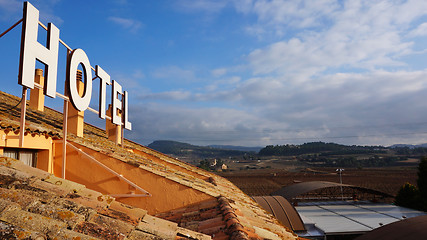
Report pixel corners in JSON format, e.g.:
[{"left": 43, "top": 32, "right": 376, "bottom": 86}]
[{"left": 0, "top": 0, "right": 427, "bottom": 146}]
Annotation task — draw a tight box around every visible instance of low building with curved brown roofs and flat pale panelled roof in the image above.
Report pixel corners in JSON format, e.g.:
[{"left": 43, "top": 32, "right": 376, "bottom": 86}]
[{"left": 253, "top": 181, "right": 427, "bottom": 240}]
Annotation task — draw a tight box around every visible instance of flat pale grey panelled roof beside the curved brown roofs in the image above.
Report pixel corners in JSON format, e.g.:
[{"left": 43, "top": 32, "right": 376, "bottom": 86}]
[{"left": 296, "top": 201, "right": 426, "bottom": 239}]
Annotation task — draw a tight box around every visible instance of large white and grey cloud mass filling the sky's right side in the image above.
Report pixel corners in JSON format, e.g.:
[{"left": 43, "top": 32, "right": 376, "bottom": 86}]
[{"left": 128, "top": 0, "right": 427, "bottom": 146}]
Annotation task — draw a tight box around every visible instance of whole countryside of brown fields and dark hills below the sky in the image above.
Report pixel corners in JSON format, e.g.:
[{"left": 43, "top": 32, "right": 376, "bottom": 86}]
[{"left": 149, "top": 141, "right": 427, "bottom": 200}]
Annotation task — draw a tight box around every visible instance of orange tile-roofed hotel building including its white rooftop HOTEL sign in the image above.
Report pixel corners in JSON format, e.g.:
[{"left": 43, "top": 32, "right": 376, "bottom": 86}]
[{"left": 0, "top": 2, "right": 297, "bottom": 239}]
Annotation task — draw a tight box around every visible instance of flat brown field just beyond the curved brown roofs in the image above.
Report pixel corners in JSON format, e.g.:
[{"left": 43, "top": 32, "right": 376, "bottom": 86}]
[{"left": 219, "top": 167, "right": 417, "bottom": 199}]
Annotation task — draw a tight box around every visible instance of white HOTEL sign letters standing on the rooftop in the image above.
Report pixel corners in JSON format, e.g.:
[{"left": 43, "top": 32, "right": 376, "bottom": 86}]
[{"left": 18, "top": 2, "right": 132, "bottom": 130}]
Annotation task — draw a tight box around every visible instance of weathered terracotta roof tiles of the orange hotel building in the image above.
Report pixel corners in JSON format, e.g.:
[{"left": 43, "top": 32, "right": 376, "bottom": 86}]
[{"left": 0, "top": 92, "right": 297, "bottom": 239}]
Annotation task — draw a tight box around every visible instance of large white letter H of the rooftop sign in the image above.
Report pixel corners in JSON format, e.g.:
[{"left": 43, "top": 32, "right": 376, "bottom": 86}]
[{"left": 18, "top": 2, "right": 59, "bottom": 98}]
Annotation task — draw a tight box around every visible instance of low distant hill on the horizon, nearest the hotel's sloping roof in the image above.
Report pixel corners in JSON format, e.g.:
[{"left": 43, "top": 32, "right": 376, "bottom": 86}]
[{"left": 147, "top": 140, "right": 254, "bottom": 159}]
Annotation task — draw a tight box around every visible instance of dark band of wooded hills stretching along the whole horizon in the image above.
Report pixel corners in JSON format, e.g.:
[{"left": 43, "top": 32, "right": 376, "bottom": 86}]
[{"left": 148, "top": 140, "right": 427, "bottom": 170}]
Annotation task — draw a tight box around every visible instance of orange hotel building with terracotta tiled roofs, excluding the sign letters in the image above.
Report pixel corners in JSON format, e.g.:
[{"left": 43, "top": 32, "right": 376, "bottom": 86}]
[{"left": 0, "top": 87, "right": 297, "bottom": 239}]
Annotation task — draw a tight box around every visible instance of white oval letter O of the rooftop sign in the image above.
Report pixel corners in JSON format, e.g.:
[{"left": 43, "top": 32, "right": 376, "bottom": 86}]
[{"left": 67, "top": 48, "right": 92, "bottom": 111}]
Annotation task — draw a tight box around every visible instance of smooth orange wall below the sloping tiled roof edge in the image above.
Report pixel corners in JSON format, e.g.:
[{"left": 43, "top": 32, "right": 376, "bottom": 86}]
[{"left": 54, "top": 141, "right": 214, "bottom": 214}]
